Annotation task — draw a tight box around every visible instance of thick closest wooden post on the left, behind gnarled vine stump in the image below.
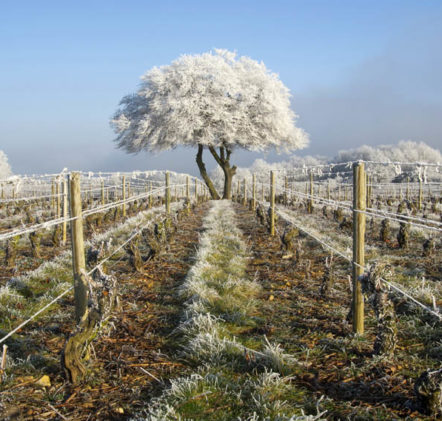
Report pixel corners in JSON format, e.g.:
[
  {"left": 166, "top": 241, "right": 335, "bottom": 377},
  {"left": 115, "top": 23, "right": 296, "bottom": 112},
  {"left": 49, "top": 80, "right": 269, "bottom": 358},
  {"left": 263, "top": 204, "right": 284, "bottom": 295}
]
[{"left": 69, "top": 173, "right": 88, "bottom": 323}]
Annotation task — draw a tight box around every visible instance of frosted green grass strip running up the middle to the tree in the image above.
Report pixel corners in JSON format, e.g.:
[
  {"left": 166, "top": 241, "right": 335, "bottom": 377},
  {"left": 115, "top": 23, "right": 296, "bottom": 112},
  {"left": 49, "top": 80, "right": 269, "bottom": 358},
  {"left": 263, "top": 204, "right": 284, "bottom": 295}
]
[{"left": 136, "top": 201, "right": 322, "bottom": 421}]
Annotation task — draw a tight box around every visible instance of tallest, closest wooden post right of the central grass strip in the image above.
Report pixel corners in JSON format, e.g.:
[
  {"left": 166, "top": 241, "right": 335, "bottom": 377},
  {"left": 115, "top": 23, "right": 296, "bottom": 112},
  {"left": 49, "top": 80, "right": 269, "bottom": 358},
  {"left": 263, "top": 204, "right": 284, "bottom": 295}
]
[{"left": 352, "top": 162, "right": 367, "bottom": 335}]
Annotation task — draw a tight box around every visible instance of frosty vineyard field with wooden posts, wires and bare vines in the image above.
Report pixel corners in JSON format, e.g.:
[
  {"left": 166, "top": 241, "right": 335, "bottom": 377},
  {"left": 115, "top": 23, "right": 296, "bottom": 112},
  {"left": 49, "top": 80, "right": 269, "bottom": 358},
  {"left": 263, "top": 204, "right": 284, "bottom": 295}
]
[{"left": 0, "top": 161, "right": 442, "bottom": 420}]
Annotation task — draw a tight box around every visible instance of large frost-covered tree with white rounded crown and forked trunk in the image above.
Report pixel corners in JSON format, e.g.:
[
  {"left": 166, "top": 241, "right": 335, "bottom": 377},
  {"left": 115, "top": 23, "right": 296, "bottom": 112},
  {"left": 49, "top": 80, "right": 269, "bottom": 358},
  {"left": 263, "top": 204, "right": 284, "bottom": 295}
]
[{"left": 111, "top": 50, "right": 308, "bottom": 199}]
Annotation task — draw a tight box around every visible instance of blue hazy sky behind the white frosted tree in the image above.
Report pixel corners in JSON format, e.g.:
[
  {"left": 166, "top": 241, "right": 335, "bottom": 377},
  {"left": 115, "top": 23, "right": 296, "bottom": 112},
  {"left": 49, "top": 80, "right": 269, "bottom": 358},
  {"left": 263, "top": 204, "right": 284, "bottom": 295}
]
[{"left": 0, "top": 0, "right": 442, "bottom": 173}]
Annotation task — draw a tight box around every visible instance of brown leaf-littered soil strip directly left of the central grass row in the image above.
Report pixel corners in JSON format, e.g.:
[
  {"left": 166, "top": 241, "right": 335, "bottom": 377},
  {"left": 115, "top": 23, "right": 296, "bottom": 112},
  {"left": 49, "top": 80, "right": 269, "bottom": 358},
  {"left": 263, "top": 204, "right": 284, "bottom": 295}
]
[{"left": 1, "top": 204, "right": 208, "bottom": 421}]
